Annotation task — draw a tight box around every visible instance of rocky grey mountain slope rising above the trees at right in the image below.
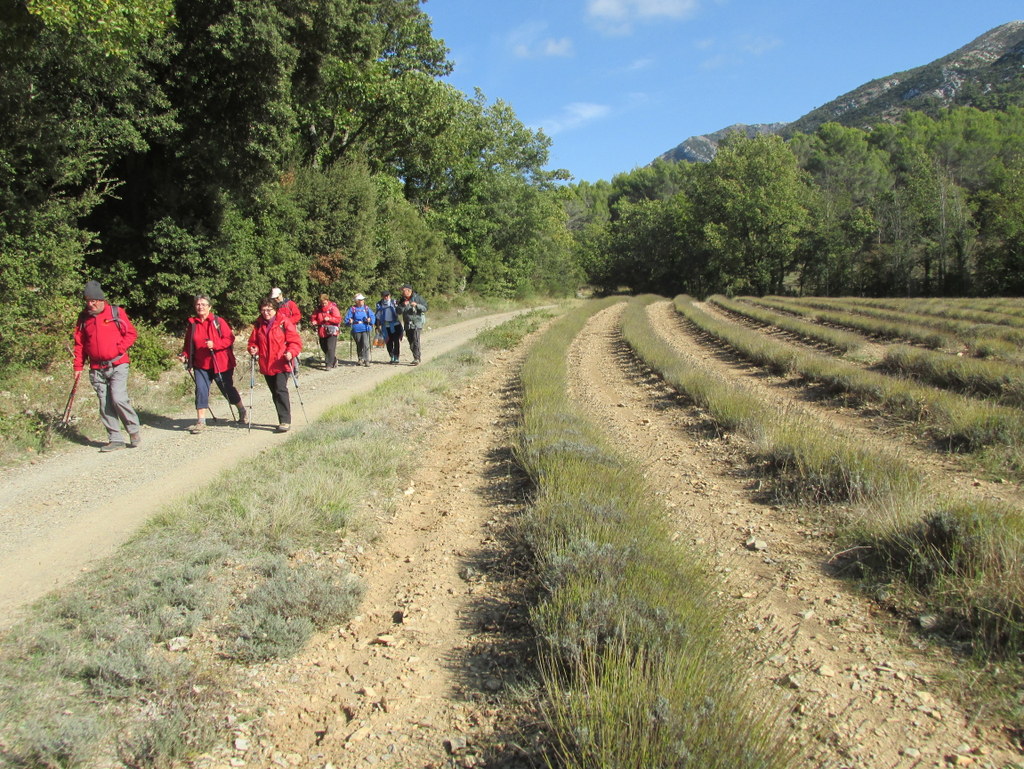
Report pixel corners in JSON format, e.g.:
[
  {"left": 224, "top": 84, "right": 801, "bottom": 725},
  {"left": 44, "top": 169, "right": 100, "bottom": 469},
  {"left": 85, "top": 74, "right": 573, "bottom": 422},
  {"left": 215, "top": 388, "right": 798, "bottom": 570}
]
[{"left": 658, "top": 22, "right": 1024, "bottom": 162}]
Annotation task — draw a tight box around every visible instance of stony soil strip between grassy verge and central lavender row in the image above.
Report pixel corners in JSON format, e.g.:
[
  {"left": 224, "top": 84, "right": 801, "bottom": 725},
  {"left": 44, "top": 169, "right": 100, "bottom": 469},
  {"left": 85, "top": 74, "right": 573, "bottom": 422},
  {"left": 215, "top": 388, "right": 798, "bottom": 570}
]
[{"left": 198, "top": 352, "right": 532, "bottom": 769}]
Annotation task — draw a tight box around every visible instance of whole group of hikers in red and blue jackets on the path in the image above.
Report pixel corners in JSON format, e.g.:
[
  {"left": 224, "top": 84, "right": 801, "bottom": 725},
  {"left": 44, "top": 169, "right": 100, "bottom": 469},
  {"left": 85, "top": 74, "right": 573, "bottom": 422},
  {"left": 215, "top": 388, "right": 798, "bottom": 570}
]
[{"left": 66, "top": 281, "right": 427, "bottom": 452}]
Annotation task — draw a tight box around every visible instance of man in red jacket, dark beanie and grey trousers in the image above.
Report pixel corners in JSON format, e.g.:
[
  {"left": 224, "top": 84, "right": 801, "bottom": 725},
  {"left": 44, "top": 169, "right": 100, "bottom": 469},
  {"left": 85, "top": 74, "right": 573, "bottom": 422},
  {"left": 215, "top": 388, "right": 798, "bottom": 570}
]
[{"left": 75, "top": 281, "right": 142, "bottom": 452}]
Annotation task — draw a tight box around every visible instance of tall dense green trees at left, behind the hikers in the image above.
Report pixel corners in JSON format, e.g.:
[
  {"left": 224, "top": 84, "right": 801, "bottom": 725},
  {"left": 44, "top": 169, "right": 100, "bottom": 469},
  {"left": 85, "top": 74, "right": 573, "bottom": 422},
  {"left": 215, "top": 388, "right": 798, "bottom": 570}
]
[{"left": 0, "top": 0, "right": 578, "bottom": 362}]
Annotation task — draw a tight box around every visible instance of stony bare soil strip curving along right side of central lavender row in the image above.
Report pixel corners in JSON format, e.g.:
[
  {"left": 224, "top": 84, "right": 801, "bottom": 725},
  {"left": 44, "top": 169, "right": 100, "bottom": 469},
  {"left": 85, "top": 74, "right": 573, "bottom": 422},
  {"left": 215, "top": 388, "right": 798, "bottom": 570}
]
[{"left": 570, "top": 302, "right": 1020, "bottom": 769}]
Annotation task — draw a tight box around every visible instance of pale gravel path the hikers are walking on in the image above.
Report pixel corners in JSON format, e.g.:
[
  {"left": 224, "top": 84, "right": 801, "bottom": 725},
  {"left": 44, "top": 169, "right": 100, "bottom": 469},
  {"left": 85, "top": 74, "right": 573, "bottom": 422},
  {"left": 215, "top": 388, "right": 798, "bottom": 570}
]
[{"left": 0, "top": 312, "right": 532, "bottom": 629}]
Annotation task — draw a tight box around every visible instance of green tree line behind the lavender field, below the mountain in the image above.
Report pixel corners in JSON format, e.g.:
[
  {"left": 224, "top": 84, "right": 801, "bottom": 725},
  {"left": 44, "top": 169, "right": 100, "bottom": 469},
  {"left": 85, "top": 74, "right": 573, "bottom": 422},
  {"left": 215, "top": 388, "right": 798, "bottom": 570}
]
[{"left": 564, "top": 108, "right": 1024, "bottom": 296}]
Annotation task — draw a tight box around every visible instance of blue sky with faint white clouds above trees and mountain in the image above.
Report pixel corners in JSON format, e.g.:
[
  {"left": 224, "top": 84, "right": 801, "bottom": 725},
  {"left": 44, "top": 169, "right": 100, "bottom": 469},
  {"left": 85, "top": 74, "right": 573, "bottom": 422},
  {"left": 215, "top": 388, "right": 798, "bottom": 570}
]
[{"left": 421, "top": 0, "right": 1024, "bottom": 181}]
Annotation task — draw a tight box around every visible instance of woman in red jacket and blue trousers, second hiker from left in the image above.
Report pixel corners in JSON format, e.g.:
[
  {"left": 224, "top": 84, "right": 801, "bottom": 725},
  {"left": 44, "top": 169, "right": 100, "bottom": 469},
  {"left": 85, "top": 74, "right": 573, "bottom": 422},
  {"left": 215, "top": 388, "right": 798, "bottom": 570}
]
[{"left": 178, "top": 294, "right": 246, "bottom": 435}]
